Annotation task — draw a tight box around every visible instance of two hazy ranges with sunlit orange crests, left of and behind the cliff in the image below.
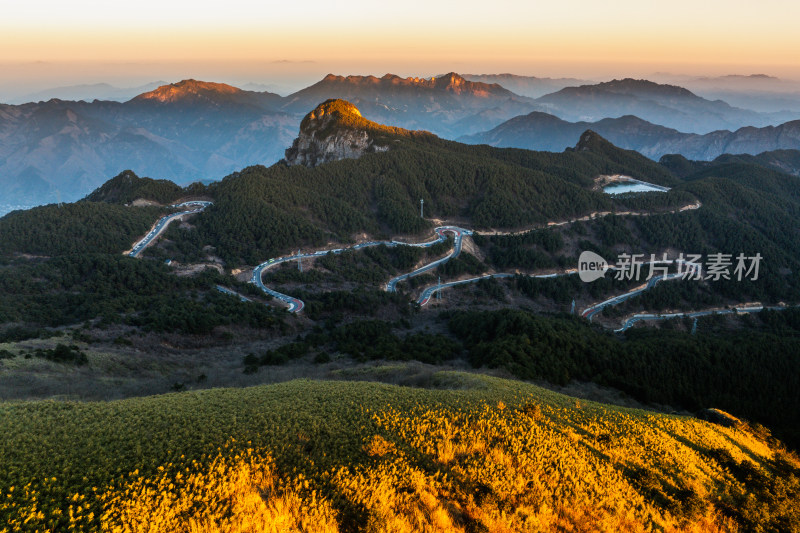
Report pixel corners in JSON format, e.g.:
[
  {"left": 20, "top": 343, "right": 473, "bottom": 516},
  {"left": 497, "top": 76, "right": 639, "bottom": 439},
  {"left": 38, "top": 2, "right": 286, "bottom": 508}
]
[{"left": 0, "top": 73, "right": 533, "bottom": 204}]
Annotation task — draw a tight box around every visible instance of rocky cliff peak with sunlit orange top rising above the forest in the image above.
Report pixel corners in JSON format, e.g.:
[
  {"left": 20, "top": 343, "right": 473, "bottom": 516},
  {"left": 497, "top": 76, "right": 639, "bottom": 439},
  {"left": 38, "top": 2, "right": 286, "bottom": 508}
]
[{"left": 286, "top": 100, "right": 389, "bottom": 167}]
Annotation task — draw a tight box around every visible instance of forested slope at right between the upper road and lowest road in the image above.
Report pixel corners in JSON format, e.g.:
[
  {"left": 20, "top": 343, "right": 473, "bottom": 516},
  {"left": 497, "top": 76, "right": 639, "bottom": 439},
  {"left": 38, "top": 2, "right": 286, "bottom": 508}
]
[{"left": 473, "top": 157, "right": 800, "bottom": 308}]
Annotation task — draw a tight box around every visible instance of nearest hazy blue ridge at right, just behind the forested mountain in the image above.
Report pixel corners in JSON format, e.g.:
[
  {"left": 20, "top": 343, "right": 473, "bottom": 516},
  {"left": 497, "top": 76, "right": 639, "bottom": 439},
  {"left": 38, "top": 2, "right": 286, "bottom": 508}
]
[{"left": 458, "top": 112, "right": 800, "bottom": 161}]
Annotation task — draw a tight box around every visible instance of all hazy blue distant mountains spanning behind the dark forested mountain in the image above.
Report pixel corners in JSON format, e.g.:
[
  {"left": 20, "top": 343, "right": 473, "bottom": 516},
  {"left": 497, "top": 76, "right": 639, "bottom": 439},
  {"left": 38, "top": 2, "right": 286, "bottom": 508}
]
[{"left": 0, "top": 73, "right": 800, "bottom": 204}]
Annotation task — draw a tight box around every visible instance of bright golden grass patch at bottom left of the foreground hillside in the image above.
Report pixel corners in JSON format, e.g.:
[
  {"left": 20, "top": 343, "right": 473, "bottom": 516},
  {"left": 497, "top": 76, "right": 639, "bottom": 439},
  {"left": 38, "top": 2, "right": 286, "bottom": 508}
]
[{"left": 100, "top": 449, "right": 338, "bottom": 533}]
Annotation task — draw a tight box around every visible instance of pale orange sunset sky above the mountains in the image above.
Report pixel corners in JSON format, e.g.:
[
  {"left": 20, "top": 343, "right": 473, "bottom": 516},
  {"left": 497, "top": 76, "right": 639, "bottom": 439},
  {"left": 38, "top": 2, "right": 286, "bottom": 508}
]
[{"left": 0, "top": 0, "right": 800, "bottom": 95}]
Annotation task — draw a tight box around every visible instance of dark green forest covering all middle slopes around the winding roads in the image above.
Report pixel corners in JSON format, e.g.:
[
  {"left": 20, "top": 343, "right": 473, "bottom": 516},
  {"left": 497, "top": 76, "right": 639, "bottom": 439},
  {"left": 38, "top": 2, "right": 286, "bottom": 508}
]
[{"left": 0, "top": 129, "right": 800, "bottom": 454}]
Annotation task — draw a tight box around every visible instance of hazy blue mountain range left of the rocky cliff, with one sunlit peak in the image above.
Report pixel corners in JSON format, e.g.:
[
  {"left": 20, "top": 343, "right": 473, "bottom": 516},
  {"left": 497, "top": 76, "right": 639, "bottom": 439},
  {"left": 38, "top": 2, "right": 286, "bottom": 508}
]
[{"left": 0, "top": 80, "right": 297, "bottom": 203}]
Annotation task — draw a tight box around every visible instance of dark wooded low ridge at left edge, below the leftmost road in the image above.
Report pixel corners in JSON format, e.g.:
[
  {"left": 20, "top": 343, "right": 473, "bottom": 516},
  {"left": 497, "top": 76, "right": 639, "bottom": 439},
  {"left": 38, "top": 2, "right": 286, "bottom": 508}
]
[{"left": 0, "top": 254, "right": 281, "bottom": 336}]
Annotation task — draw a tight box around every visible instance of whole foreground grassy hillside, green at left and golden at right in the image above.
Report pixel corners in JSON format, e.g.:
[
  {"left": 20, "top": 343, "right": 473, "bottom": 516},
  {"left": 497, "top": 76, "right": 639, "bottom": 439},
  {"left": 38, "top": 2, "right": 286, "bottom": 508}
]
[{"left": 0, "top": 372, "right": 800, "bottom": 532}]
